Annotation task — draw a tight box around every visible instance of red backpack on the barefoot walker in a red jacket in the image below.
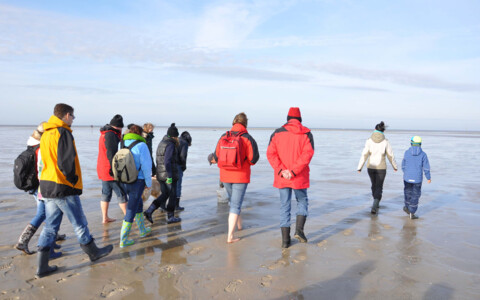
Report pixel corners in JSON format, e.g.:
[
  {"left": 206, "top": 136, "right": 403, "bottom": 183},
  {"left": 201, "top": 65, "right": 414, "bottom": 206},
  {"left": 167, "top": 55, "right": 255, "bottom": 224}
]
[{"left": 217, "top": 131, "right": 247, "bottom": 171}]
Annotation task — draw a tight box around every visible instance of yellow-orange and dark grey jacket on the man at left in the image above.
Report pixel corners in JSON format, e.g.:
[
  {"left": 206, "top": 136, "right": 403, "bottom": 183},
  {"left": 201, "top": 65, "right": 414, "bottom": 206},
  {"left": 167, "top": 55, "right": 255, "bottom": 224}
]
[{"left": 40, "top": 116, "right": 83, "bottom": 198}]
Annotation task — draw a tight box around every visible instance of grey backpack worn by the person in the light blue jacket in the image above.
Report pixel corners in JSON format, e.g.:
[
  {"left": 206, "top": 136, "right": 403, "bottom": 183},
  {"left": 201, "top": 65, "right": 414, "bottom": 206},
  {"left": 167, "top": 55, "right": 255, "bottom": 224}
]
[{"left": 112, "top": 141, "right": 141, "bottom": 183}]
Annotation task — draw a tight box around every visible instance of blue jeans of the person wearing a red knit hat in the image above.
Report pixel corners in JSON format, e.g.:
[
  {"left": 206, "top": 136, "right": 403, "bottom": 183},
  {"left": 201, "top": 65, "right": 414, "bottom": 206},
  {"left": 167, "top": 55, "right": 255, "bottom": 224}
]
[{"left": 278, "top": 188, "right": 308, "bottom": 227}]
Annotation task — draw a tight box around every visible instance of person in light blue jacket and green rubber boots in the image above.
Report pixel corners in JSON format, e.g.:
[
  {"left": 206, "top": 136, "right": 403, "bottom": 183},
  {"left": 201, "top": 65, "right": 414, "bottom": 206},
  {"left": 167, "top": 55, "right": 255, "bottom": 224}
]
[{"left": 120, "top": 124, "right": 152, "bottom": 248}]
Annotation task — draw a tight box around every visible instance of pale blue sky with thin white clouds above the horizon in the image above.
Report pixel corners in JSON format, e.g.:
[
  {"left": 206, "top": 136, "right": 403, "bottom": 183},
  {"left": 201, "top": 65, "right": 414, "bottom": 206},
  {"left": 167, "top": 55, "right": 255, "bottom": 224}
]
[{"left": 0, "top": 0, "right": 480, "bottom": 131}]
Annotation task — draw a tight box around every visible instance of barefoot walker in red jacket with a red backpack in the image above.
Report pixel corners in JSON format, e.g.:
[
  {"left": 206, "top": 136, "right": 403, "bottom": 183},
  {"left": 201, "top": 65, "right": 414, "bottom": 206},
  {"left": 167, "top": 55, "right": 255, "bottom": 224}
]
[{"left": 213, "top": 113, "right": 260, "bottom": 243}]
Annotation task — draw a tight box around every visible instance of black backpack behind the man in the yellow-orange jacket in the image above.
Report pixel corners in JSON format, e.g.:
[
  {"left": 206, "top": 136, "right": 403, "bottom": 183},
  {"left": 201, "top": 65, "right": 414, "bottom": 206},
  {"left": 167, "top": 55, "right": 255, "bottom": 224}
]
[{"left": 13, "top": 145, "right": 40, "bottom": 192}]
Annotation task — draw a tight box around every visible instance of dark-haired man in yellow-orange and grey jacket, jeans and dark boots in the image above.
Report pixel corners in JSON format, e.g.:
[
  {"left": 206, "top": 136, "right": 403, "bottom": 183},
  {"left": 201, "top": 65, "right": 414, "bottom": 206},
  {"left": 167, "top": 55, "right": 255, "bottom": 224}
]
[{"left": 36, "top": 103, "right": 113, "bottom": 277}]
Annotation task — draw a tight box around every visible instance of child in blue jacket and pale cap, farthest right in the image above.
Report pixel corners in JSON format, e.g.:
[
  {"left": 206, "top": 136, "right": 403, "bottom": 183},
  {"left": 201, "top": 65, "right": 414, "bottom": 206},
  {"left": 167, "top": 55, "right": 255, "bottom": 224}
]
[{"left": 402, "top": 136, "right": 432, "bottom": 219}]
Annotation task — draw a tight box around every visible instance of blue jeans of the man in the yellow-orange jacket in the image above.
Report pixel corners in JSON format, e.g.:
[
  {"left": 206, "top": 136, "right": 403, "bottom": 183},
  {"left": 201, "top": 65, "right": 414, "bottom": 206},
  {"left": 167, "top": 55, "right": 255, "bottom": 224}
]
[{"left": 38, "top": 195, "right": 92, "bottom": 250}]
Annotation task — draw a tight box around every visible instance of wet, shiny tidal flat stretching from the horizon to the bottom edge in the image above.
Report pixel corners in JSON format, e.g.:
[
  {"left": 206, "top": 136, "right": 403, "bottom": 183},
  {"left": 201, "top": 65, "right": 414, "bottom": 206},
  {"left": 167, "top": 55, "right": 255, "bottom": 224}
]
[{"left": 0, "top": 126, "right": 480, "bottom": 299}]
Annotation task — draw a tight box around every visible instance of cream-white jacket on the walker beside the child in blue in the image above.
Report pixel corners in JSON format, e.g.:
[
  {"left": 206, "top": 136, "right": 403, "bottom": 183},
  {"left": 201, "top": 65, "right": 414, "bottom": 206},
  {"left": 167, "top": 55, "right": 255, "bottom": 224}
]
[{"left": 356, "top": 131, "right": 398, "bottom": 171}]
